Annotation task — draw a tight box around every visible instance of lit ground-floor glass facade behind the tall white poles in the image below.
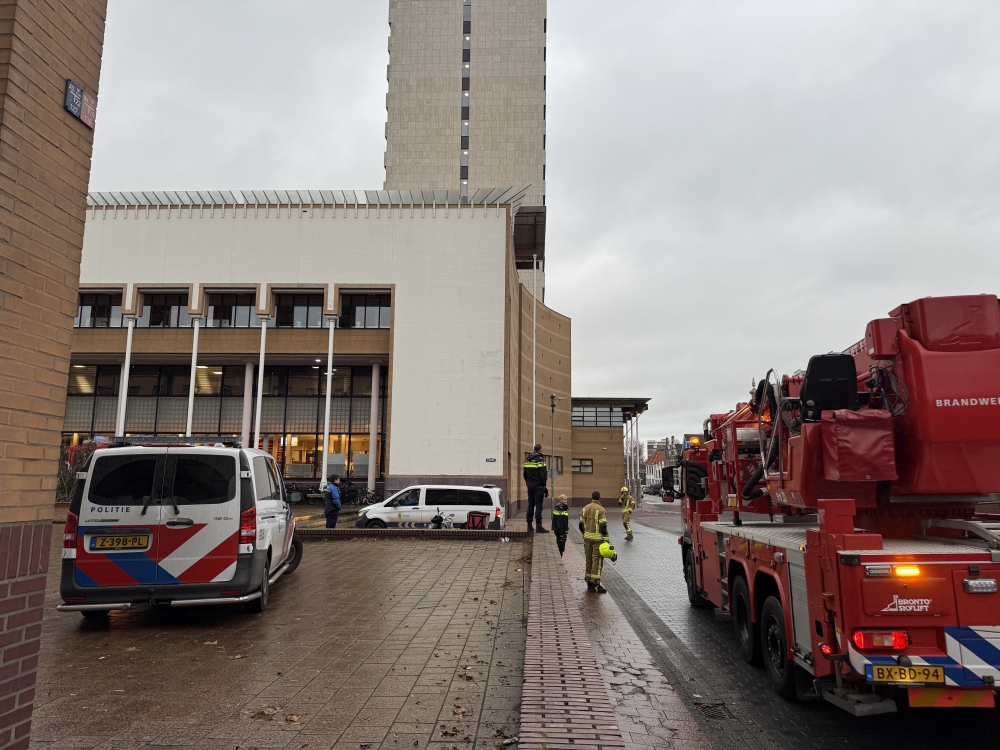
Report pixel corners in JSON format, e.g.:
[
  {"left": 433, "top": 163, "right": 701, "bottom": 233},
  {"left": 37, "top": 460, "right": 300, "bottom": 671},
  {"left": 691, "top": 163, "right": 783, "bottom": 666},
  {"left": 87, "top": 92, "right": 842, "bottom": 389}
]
[{"left": 63, "top": 364, "right": 388, "bottom": 480}]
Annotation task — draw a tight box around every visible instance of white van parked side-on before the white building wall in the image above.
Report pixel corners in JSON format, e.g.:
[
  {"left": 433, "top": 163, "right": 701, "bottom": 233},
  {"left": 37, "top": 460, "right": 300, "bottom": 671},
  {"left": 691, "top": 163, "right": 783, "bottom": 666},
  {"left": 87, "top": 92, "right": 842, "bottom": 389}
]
[{"left": 357, "top": 484, "right": 506, "bottom": 529}]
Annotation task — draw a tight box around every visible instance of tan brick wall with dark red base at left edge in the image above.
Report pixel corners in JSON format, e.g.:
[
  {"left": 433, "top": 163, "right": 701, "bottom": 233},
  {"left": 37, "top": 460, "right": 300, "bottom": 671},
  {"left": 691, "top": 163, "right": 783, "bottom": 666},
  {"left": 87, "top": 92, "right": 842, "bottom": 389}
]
[{"left": 0, "top": 0, "right": 107, "bottom": 748}]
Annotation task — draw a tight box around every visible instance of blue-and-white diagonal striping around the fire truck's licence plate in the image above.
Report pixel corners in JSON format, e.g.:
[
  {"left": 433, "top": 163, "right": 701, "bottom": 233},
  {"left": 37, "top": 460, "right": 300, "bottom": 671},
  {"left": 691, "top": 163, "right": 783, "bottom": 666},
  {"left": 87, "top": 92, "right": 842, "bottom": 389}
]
[{"left": 847, "top": 626, "right": 1000, "bottom": 692}]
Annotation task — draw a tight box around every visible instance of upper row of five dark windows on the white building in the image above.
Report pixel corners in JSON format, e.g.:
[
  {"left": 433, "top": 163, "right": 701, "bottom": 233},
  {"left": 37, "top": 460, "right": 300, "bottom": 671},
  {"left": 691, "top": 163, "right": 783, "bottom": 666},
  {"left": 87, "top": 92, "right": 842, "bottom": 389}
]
[{"left": 73, "top": 293, "right": 391, "bottom": 328}]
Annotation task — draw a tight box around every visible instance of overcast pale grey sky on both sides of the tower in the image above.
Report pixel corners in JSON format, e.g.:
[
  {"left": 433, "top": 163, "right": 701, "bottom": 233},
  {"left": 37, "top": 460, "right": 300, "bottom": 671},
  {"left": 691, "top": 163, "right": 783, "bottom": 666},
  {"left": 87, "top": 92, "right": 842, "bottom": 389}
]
[{"left": 91, "top": 0, "right": 1000, "bottom": 446}]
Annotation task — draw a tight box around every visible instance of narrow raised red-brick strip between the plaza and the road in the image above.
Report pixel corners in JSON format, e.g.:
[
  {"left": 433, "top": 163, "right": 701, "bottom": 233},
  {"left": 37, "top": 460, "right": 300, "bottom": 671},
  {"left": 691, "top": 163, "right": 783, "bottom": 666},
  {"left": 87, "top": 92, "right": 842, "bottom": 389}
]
[{"left": 519, "top": 534, "right": 625, "bottom": 750}]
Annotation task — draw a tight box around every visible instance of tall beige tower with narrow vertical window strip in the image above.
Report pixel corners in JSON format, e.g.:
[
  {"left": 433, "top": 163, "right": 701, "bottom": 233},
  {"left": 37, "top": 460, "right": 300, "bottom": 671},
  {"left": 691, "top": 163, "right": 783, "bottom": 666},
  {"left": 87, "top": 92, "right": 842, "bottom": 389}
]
[{"left": 385, "top": 0, "right": 546, "bottom": 206}]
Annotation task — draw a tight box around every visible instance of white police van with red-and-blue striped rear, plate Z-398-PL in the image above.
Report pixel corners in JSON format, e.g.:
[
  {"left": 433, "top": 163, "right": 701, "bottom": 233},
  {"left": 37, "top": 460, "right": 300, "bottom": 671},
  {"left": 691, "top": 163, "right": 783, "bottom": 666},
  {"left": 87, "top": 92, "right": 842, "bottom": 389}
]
[{"left": 58, "top": 437, "right": 302, "bottom": 617}]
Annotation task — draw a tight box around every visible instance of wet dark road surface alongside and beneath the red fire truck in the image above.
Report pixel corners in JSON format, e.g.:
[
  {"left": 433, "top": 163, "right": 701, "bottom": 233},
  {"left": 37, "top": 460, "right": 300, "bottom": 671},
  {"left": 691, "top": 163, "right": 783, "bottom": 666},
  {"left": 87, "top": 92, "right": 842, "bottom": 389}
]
[{"left": 588, "top": 497, "right": 1000, "bottom": 750}]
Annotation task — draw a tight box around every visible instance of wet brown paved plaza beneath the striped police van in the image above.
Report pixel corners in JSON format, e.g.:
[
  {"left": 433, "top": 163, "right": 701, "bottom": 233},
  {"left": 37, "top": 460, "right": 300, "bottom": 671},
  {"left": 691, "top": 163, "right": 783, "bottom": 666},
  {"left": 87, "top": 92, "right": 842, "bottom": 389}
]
[{"left": 32, "top": 528, "right": 527, "bottom": 750}]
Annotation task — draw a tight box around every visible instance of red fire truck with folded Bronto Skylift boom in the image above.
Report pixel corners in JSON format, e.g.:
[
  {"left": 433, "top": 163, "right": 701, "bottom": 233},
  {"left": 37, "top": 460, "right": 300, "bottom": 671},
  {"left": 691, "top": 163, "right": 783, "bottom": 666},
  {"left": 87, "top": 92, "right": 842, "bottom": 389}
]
[{"left": 676, "top": 295, "right": 1000, "bottom": 716}]
